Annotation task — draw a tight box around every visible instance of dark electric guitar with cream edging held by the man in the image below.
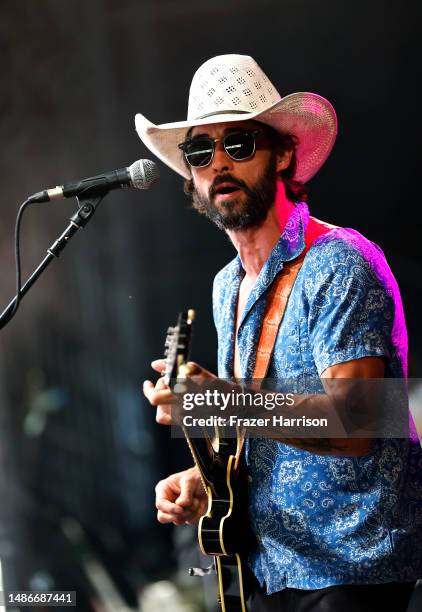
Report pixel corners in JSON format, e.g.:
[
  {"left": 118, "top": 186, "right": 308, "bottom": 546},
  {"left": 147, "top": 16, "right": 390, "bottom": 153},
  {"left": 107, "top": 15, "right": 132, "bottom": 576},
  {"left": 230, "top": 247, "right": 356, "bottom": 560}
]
[{"left": 163, "top": 310, "right": 252, "bottom": 612}]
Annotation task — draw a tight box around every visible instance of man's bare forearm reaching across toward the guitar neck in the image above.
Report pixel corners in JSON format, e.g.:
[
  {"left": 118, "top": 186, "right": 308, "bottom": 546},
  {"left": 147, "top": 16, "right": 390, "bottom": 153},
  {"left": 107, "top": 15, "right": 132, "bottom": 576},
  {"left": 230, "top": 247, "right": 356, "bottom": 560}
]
[{"left": 183, "top": 379, "right": 378, "bottom": 455}]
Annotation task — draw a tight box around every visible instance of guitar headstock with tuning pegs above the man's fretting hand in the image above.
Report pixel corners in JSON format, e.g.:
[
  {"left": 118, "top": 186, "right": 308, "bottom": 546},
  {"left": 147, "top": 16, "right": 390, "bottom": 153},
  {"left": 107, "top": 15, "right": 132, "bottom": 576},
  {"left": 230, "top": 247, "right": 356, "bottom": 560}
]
[{"left": 163, "top": 309, "right": 195, "bottom": 384}]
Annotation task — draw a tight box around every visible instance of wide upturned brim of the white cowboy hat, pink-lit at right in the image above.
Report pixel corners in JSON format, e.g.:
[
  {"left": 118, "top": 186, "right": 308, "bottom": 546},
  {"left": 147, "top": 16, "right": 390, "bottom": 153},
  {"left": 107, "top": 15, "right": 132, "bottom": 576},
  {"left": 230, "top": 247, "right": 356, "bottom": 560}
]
[{"left": 135, "top": 92, "right": 337, "bottom": 183}]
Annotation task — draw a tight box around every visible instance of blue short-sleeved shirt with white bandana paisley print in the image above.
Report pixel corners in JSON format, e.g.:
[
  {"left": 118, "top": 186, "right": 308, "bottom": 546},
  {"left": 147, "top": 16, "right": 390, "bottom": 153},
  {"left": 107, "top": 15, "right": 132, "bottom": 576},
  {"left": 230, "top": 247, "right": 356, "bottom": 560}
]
[{"left": 213, "top": 203, "right": 422, "bottom": 593}]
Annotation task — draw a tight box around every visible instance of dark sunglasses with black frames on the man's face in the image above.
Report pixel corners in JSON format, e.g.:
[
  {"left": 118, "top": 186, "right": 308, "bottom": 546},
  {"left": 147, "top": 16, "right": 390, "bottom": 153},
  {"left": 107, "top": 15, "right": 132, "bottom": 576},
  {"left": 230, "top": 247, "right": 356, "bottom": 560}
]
[{"left": 178, "top": 130, "right": 261, "bottom": 168}]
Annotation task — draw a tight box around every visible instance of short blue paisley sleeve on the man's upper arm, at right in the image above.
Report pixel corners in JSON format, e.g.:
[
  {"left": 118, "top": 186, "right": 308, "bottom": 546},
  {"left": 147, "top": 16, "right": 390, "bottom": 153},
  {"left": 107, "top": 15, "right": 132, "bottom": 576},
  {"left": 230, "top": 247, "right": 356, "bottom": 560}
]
[{"left": 304, "top": 240, "right": 394, "bottom": 374}]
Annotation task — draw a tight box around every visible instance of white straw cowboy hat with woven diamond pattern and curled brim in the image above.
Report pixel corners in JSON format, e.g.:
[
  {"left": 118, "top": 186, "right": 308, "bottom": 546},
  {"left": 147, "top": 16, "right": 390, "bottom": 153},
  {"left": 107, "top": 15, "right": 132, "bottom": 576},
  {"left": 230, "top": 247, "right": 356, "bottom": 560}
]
[{"left": 135, "top": 55, "right": 337, "bottom": 183}]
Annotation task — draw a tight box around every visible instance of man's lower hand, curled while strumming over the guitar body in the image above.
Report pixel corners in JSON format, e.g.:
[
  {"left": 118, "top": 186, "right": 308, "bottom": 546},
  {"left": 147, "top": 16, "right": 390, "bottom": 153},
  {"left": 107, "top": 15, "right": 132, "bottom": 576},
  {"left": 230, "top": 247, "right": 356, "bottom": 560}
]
[{"left": 155, "top": 467, "right": 208, "bottom": 525}]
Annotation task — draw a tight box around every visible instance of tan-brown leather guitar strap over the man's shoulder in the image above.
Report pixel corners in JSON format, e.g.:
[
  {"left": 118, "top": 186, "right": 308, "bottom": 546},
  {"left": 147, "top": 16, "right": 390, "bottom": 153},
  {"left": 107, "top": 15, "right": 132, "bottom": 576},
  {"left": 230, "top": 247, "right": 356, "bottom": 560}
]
[{"left": 253, "top": 217, "right": 336, "bottom": 380}]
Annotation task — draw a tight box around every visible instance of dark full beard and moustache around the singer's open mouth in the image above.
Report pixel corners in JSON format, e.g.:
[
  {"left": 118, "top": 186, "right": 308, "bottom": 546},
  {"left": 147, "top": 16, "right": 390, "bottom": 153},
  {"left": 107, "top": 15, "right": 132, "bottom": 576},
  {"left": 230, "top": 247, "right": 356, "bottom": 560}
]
[{"left": 192, "top": 153, "right": 277, "bottom": 230}]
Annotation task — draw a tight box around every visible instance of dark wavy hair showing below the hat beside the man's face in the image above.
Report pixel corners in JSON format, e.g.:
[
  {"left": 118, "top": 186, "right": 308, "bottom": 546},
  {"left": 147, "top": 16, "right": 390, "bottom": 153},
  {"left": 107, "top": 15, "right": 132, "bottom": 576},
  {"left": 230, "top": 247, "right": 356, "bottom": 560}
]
[{"left": 183, "top": 123, "right": 308, "bottom": 202}]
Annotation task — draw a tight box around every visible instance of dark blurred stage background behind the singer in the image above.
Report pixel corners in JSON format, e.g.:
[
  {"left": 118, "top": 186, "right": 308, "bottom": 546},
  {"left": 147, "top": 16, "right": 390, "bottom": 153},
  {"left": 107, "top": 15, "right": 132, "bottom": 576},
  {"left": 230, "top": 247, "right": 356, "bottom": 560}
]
[{"left": 0, "top": 0, "right": 422, "bottom": 609}]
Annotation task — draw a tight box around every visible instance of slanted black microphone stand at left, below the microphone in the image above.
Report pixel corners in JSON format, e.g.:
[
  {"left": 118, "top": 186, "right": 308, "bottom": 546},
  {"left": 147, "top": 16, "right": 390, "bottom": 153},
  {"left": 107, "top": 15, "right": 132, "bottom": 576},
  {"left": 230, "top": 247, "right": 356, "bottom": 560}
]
[{"left": 0, "top": 190, "right": 108, "bottom": 329}]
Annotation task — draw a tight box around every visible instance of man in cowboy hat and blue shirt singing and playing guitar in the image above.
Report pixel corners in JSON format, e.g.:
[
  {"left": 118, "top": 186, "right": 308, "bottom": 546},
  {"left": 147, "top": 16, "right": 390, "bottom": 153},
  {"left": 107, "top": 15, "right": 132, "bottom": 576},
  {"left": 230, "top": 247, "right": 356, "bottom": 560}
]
[{"left": 136, "top": 55, "right": 422, "bottom": 612}]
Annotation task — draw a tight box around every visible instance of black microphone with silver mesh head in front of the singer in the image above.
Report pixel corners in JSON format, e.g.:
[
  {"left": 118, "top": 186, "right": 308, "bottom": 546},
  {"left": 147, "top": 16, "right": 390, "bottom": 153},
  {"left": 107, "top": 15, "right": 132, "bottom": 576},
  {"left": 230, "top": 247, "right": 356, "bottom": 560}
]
[{"left": 27, "top": 159, "right": 160, "bottom": 202}]
